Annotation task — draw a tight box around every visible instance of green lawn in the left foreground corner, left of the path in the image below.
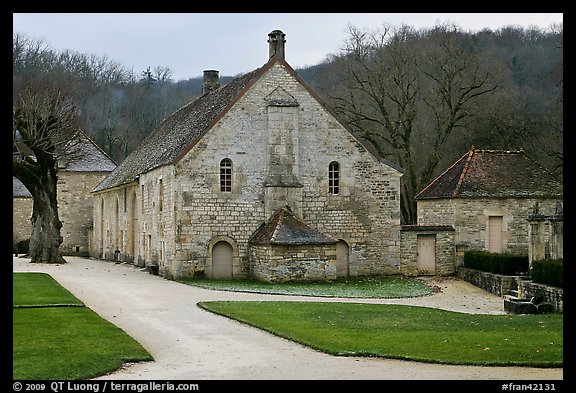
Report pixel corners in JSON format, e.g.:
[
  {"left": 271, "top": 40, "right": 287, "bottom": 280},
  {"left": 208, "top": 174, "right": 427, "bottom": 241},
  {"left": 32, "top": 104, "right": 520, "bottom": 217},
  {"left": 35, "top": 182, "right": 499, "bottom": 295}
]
[{"left": 12, "top": 273, "right": 153, "bottom": 380}]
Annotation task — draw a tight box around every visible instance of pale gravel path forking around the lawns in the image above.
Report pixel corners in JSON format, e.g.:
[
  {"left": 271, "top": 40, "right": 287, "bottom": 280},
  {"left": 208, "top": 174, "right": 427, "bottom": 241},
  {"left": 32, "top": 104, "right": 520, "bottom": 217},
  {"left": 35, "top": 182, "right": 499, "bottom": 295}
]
[{"left": 13, "top": 257, "right": 563, "bottom": 381}]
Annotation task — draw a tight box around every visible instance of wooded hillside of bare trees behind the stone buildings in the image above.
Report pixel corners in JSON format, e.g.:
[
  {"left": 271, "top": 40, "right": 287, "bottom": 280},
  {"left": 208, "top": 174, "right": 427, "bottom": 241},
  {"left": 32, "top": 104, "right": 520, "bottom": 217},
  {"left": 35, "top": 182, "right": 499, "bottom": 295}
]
[{"left": 13, "top": 24, "right": 563, "bottom": 223}]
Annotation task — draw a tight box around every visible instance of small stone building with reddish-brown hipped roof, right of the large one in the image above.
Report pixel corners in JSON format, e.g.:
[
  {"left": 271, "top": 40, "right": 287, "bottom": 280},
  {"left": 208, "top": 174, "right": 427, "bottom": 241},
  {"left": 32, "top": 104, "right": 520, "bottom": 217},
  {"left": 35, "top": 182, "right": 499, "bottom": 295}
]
[{"left": 402, "top": 147, "right": 563, "bottom": 272}]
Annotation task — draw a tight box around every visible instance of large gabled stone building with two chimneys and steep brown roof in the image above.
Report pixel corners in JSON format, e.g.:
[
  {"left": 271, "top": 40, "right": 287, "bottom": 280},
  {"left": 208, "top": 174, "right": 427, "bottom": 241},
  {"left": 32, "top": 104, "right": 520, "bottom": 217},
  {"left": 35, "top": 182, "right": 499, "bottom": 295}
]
[{"left": 91, "top": 30, "right": 402, "bottom": 281}]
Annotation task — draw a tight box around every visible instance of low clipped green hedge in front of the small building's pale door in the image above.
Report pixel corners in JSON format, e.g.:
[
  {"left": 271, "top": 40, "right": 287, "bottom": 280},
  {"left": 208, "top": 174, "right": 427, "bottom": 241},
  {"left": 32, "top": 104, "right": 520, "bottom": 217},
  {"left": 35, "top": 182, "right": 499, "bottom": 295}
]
[{"left": 464, "top": 251, "right": 528, "bottom": 276}]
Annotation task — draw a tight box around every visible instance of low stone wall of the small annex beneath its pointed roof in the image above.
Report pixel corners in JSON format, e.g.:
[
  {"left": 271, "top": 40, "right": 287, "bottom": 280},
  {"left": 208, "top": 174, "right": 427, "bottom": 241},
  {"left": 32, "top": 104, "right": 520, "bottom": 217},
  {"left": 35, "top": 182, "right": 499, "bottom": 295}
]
[{"left": 250, "top": 244, "right": 336, "bottom": 282}]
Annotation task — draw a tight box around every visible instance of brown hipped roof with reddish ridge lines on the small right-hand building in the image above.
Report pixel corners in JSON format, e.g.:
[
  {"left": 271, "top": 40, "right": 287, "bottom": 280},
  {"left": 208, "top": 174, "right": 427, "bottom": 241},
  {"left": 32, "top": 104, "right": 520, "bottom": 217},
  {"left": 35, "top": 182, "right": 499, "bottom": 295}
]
[{"left": 415, "top": 147, "right": 563, "bottom": 200}]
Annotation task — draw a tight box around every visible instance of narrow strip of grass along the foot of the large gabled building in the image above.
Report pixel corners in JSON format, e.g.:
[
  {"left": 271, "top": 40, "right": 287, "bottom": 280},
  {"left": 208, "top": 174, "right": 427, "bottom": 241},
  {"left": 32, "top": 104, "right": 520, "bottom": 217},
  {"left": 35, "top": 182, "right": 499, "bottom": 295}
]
[{"left": 179, "top": 276, "right": 432, "bottom": 299}]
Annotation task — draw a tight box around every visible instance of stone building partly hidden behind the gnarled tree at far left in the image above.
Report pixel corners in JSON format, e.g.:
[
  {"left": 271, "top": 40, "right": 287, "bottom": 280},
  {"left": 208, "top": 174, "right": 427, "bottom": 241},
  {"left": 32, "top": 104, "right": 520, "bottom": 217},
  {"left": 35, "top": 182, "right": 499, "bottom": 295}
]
[{"left": 12, "top": 134, "right": 116, "bottom": 256}]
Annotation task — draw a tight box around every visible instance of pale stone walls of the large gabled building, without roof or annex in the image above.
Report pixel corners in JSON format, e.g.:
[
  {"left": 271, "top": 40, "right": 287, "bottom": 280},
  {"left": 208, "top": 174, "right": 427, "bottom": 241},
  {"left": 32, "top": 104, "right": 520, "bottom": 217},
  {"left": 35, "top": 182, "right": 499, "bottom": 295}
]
[{"left": 93, "top": 31, "right": 402, "bottom": 279}]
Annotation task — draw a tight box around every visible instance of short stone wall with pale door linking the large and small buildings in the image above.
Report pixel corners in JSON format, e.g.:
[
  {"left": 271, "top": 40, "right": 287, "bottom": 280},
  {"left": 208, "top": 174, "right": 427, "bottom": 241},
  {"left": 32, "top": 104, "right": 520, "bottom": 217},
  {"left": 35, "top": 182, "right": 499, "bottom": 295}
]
[{"left": 400, "top": 225, "right": 456, "bottom": 276}]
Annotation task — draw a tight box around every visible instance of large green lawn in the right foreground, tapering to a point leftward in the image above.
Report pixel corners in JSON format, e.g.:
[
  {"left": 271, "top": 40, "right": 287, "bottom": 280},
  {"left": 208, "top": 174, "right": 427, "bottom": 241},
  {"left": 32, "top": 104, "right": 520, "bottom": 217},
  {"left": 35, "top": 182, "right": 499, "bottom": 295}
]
[{"left": 198, "top": 301, "right": 563, "bottom": 367}]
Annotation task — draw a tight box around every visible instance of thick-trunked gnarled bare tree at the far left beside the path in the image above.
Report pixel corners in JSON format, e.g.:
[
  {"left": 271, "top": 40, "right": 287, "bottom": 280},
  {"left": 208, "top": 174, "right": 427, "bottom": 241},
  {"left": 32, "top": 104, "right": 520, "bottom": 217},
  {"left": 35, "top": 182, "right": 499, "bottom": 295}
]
[{"left": 12, "top": 86, "right": 81, "bottom": 263}]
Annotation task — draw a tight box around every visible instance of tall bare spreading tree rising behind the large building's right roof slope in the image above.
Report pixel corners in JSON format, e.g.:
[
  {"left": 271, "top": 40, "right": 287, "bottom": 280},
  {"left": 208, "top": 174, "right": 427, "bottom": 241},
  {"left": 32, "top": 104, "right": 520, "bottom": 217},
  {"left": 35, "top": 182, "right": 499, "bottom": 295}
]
[{"left": 331, "top": 25, "right": 496, "bottom": 224}]
